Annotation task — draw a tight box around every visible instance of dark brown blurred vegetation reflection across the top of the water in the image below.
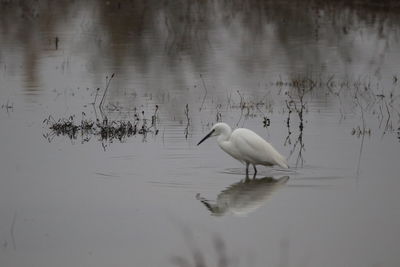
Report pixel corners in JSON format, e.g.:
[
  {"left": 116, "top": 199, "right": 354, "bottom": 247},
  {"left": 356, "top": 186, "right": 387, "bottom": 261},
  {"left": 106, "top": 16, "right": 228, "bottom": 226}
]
[{"left": 0, "top": 0, "right": 400, "bottom": 90}]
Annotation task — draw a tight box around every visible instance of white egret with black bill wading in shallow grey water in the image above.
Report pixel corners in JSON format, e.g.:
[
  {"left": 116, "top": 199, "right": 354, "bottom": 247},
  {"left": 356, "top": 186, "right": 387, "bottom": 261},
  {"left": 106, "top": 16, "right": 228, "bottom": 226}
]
[{"left": 197, "top": 122, "right": 289, "bottom": 175}]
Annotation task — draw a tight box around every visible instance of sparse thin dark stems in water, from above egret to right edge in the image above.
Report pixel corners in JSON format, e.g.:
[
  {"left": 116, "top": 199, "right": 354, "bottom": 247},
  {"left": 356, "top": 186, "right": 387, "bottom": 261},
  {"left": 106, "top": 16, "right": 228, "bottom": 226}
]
[{"left": 223, "top": 75, "right": 400, "bottom": 140}]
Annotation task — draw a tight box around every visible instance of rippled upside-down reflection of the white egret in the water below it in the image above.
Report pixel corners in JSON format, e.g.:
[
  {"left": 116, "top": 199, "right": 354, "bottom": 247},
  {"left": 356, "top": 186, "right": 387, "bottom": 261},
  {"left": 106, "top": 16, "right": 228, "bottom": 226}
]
[{"left": 196, "top": 176, "right": 289, "bottom": 216}]
